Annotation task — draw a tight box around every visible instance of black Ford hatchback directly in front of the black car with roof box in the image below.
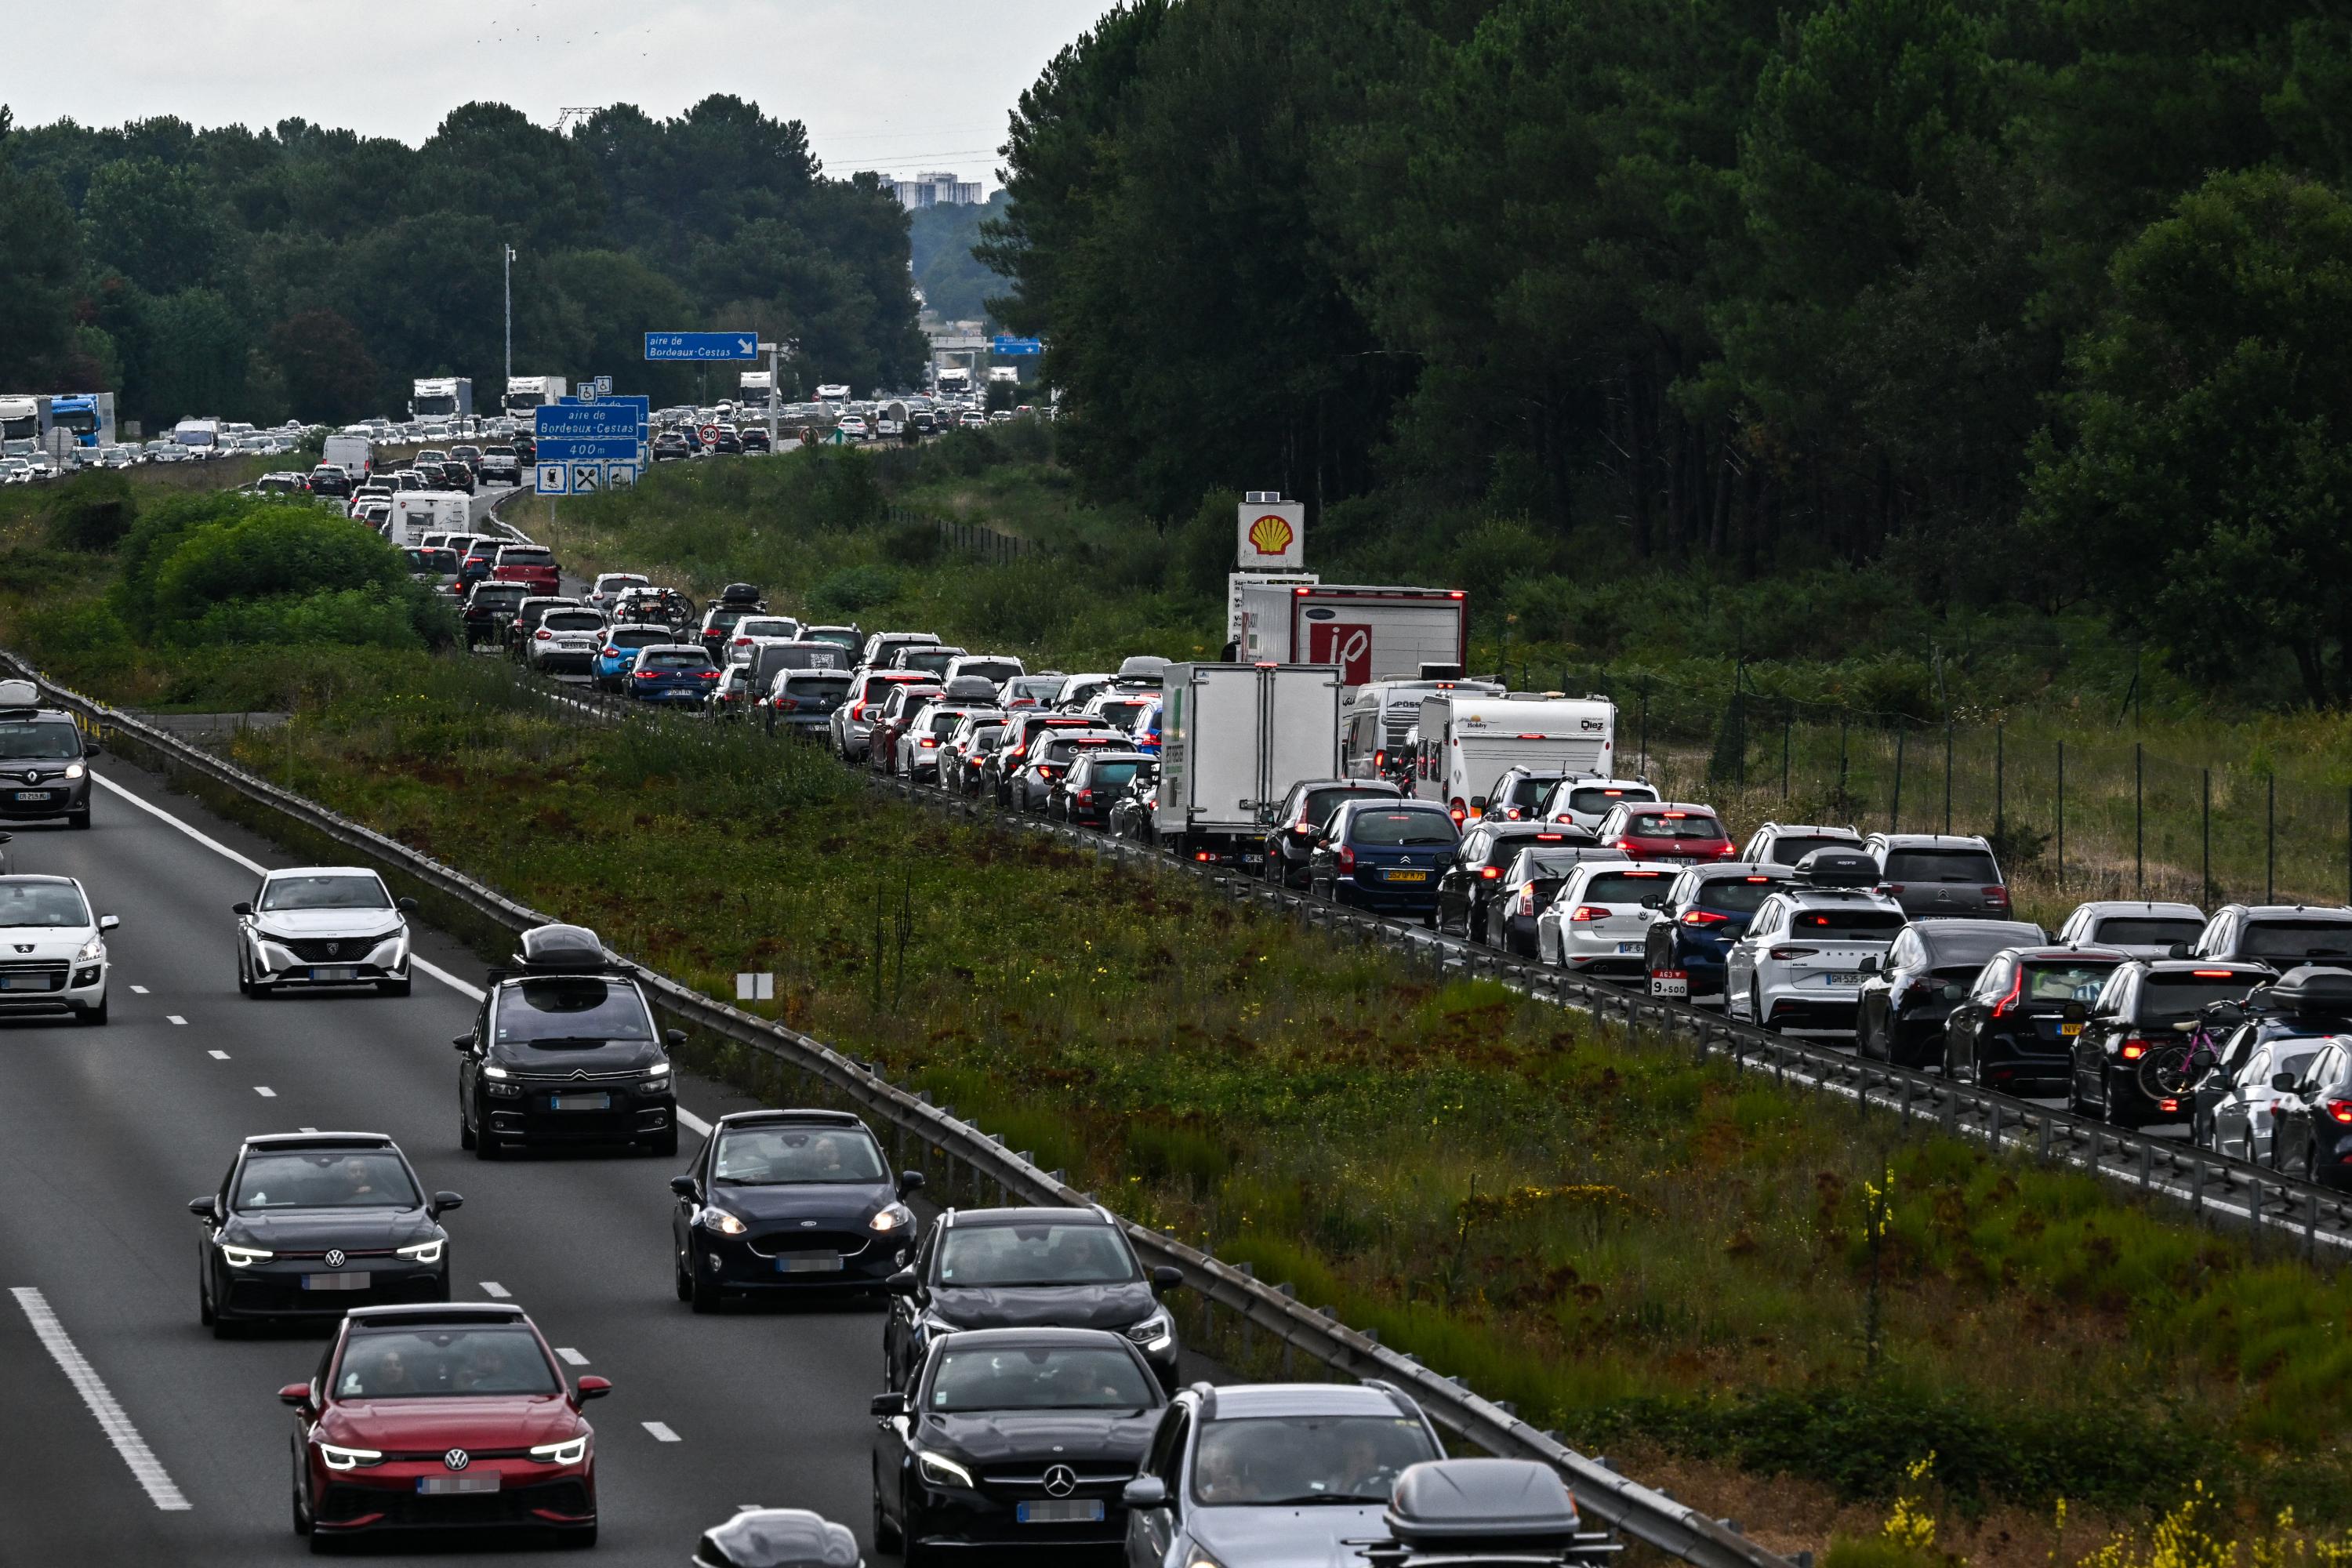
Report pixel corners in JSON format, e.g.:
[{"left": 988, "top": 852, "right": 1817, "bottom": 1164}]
[{"left": 670, "top": 1109, "right": 922, "bottom": 1312}]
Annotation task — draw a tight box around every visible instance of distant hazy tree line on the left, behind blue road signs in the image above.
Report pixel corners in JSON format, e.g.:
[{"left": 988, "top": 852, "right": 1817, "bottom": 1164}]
[{"left": 0, "top": 96, "right": 924, "bottom": 430}]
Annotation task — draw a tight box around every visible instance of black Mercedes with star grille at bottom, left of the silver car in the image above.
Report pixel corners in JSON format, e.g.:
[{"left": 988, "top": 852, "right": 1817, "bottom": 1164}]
[{"left": 873, "top": 1328, "right": 1167, "bottom": 1568}]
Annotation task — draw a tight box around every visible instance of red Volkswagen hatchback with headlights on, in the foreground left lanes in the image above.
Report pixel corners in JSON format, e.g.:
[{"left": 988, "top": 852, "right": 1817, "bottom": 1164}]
[{"left": 278, "top": 1302, "right": 612, "bottom": 1549}]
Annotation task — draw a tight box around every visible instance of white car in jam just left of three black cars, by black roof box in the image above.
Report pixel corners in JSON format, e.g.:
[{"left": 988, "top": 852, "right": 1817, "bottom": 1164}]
[{"left": 1724, "top": 884, "right": 1910, "bottom": 1029}]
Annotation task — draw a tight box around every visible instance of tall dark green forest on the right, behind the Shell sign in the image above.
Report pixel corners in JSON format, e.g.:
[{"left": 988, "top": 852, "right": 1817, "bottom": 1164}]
[{"left": 981, "top": 0, "right": 2352, "bottom": 706}]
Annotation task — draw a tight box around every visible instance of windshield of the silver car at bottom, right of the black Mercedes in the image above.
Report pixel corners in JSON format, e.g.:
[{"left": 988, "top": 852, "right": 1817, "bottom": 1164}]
[{"left": 1192, "top": 1415, "right": 1444, "bottom": 1507}]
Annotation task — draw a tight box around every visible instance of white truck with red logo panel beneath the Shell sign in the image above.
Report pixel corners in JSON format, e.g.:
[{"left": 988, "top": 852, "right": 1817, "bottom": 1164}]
[{"left": 1237, "top": 581, "right": 1470, "bottom": 689}]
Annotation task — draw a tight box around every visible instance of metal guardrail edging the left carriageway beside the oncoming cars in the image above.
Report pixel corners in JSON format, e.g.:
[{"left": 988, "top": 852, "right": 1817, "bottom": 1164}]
[{"left": 0, "top": 652, "right": 1792, "bottom": 1568}]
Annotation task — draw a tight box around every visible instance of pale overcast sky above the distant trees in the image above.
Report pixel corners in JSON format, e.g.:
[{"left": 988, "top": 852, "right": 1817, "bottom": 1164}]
[{"left": 0, "top": 0, "right": 1110, "bottom": 188}]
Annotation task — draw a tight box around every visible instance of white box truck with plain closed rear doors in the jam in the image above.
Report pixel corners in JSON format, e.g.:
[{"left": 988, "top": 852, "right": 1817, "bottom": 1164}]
[{"left": 1152, "top": 663, "right": 1341, "bottom": 860}]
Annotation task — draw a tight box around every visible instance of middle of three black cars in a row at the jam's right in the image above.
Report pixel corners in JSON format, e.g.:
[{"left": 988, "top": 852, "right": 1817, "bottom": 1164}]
[{"left": 1912, "top": 945, "right": 2129, "bottom": 1095}]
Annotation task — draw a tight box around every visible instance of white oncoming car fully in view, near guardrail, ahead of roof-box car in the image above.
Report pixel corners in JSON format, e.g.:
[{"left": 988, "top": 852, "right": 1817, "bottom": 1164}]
[{"left": 235, "top": 865, "right": 416, "bottom": 996}]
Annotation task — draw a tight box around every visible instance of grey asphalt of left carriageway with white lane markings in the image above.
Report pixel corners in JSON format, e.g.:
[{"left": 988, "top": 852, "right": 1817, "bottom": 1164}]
[{"left": 0, "top": 760, "right": 882, "bottom": 1566}]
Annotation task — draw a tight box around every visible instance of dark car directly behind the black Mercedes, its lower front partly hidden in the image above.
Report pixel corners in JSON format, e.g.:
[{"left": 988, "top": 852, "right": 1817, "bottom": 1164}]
[{"left": 882, "top": 1208, "right": 1183, "bottom": 1389}]
